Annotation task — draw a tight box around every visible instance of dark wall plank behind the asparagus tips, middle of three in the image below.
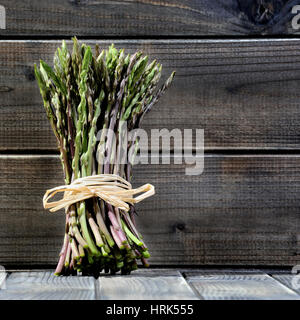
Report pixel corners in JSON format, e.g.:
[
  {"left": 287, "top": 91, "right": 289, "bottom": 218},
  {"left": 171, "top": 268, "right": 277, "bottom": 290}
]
[{"left": 0, "top": 40, "right": 300, "bottom": 151}]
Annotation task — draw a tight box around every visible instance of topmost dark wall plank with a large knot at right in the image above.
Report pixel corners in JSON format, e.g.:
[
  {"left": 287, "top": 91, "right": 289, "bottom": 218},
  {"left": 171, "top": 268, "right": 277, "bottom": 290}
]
[{"left": 1, "top": 0, "right": 299, "bottom": 37}]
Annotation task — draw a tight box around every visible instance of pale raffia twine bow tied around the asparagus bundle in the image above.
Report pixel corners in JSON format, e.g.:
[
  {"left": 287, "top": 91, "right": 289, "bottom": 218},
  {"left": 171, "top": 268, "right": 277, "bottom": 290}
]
[{"left": 43, "top": 174, "right": 155, "bottom": 212}]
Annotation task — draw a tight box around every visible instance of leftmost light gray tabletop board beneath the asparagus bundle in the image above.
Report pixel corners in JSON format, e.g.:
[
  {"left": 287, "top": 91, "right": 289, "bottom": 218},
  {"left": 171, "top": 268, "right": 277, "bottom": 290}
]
[{"left": 0, "top": 271, "right": 95, "bottom": 300}]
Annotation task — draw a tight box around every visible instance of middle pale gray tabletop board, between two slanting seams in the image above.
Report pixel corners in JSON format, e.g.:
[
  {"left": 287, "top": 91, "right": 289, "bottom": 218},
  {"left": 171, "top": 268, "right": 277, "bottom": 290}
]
[{"left": 97, "top": 270, "right": 198, "bottom": 300}]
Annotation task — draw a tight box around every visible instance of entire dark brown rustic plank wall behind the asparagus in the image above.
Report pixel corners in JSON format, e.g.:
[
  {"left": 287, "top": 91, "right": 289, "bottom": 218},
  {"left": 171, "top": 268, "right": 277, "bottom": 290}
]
[{"left": 0, "top": 0, "right": 300, "bottom": 267}]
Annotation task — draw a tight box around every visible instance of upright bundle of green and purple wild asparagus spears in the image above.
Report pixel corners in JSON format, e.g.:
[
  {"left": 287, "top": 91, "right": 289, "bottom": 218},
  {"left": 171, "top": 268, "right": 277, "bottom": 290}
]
[{"left": 35, "top": 38, "right": 174, "bottom": 277}]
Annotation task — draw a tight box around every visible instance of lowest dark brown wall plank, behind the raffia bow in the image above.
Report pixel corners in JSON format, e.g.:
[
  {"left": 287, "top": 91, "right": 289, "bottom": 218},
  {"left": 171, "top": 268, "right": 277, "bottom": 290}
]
[{"left": 0, "top": 155, "right": 300, "bottom": 267}]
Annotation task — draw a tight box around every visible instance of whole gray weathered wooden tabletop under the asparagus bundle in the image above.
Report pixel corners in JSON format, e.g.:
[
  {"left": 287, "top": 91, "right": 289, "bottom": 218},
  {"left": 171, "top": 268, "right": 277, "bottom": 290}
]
[{"left": 0, "top": 269, "right": 300, "bottom": 300}]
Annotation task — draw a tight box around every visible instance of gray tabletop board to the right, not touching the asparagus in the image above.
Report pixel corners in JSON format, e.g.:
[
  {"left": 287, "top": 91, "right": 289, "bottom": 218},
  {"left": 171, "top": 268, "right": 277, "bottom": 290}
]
[{"left": 187, "top": 270, "right": 300, "bottom": 300}]
